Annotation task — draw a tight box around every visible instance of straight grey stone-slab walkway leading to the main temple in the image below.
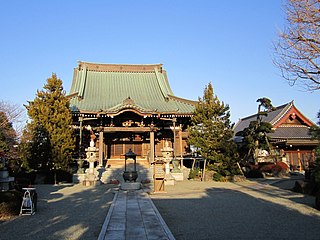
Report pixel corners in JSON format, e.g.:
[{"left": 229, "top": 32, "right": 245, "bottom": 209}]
[{"left": 98, "top": 190, "right": 175, "bottom": 240}]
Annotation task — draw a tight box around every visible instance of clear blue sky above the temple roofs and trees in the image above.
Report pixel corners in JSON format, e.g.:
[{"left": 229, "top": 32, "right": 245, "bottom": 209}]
[{"left": 0, "top": 0, "right": 320, "bottom": 122}]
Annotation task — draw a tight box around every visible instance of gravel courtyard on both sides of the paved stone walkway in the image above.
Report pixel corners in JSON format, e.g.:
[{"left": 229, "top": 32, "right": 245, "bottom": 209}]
[{"left": 0, "top": 177, "right": 320, "bottom": 240}]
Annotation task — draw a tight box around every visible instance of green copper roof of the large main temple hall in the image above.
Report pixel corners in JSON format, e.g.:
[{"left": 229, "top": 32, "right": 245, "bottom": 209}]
[{"left": 70, "top": 62, "right": 195, "bottom": 114}]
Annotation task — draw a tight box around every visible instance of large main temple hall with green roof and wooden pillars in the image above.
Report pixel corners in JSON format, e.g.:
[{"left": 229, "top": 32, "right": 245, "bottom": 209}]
[{"left": 69, "top": 62, "right": 196, "bottom": 166}]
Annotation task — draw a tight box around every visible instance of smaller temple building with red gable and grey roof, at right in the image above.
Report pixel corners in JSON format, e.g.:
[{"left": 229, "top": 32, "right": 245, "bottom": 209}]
[{"left": 234, "top": 101, "right": 319, "bottom": 170}]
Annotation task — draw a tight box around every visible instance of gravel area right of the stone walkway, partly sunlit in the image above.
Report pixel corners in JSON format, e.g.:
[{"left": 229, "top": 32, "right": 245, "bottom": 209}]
[{"left": 151, "top": 180, "right": 320, "bottom": 240}]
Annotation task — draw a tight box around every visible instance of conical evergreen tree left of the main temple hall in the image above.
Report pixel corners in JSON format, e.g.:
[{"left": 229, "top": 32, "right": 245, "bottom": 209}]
[{"left": 27, "top": 74, "right": 75, "bottom": 170}]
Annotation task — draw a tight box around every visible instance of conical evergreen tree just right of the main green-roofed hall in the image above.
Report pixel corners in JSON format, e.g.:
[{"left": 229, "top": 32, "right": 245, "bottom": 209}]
[{"left": 188, "top": 83, "right": 238, "bottom": 176}]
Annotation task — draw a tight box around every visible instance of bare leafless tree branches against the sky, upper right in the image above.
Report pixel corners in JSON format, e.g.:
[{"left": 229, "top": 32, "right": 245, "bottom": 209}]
[{"left": 274, "top": 0, "right": 320, "bottom": 91}]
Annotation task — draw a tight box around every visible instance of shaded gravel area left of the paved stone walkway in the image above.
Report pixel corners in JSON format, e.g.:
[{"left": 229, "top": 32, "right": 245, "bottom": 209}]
[{"left": 0, "top": 184, "right": 114, "bottom": 240}]
